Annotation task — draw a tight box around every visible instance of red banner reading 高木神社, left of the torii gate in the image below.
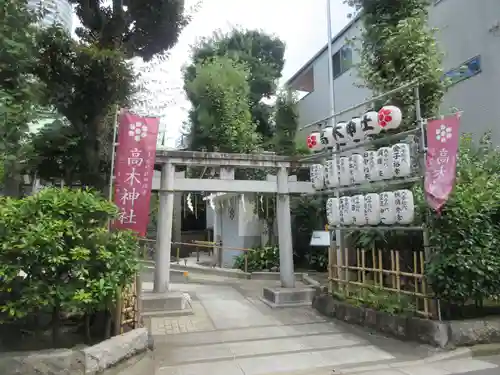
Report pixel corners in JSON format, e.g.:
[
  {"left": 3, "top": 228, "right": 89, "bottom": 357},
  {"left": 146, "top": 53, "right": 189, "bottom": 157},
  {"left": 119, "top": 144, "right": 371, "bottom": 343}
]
[{"left": 112, "top": 111, "right": 160, "bottom": 236}]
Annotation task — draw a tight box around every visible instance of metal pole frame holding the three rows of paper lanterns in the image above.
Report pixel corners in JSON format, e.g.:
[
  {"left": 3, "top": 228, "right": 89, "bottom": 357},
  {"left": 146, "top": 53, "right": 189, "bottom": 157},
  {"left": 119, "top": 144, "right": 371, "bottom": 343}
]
[{"left": 300, "top": 81, "right": 441, "bottom": 320}]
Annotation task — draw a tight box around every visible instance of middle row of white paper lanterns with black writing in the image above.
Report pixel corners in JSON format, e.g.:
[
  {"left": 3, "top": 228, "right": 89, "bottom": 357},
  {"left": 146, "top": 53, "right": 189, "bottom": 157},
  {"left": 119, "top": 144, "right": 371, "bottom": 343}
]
[{"left": 310, "top": 143, "right": 412, "bottom": 190}]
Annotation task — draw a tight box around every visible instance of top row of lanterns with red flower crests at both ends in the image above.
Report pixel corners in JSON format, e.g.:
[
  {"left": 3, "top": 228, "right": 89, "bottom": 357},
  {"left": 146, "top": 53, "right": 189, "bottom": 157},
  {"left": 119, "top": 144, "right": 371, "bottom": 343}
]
[{"left": 307, "top": 105, "right": 403, "bottom": 151}]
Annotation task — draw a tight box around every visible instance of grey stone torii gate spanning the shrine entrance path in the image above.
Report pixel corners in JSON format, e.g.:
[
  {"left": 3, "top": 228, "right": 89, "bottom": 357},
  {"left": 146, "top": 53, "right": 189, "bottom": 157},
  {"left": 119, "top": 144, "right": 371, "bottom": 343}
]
[{"left": 154, "top": 150, "right": 314, "bottom": 293}]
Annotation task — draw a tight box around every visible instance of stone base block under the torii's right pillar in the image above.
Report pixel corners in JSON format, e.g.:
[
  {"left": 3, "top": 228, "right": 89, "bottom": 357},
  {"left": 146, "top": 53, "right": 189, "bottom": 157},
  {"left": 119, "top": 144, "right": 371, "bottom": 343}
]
[{"left": 261, "top": 287, "right": 315, "bottom": 308}]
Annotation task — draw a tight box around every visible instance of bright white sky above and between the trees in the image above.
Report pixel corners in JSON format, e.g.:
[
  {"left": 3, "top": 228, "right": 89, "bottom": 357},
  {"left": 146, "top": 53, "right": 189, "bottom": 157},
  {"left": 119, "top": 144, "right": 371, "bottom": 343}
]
[{"left": 74, "top": 0, "right": 349, "bottom": 147}]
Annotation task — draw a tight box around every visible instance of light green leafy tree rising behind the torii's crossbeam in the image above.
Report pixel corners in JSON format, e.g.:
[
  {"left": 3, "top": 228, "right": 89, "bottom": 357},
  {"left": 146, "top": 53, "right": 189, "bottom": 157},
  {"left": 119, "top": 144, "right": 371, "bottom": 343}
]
[{"left": 185, "top": 57, "right": 260, "bottom": 153}]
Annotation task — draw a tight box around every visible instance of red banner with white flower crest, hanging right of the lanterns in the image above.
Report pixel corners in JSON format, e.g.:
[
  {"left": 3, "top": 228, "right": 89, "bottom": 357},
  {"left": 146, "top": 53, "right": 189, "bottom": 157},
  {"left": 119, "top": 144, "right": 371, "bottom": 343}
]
[{"left": 424, "top": 114, "right": 460, "bottom": 212}]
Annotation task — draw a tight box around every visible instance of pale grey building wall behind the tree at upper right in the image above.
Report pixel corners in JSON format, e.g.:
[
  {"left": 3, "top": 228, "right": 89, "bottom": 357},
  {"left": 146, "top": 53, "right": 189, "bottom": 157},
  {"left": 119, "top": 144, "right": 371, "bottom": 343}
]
[{"left": 292, "top": 0, "right": 500, "bottom": 143}]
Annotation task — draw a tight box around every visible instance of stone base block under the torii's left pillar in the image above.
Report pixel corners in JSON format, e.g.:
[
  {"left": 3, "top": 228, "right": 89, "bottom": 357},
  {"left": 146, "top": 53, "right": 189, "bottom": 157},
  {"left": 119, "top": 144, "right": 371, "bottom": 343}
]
[{"left": 141, "top": 292, "right": 191, "bottom": 315}]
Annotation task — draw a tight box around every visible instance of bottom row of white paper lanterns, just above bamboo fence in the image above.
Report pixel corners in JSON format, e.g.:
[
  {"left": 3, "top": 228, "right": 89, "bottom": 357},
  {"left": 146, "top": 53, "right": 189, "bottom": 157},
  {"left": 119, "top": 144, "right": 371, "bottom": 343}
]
[{"left": 326, "top": 189, "right": 415, "bottom": 227}]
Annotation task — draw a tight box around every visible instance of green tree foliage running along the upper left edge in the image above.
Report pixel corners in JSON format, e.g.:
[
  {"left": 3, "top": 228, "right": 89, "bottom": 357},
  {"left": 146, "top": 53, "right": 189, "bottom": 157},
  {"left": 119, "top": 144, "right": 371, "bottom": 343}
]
[{"left": 0, "top": 0, "right": 45, "bottom": 196}]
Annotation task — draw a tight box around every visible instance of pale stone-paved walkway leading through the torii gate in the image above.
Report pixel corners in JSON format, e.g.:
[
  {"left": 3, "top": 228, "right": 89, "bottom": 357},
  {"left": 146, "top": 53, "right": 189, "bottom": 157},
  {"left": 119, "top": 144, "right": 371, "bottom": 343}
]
[{"left": 114, "top": 275, "right": 500, "bottom": 375}]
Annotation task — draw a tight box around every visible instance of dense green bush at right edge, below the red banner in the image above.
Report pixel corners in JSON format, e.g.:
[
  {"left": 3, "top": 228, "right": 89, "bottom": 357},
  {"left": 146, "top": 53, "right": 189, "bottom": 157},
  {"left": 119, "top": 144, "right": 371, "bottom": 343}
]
[{"left": 421, "top": 134, "right": 500, "bottom": 305}]
